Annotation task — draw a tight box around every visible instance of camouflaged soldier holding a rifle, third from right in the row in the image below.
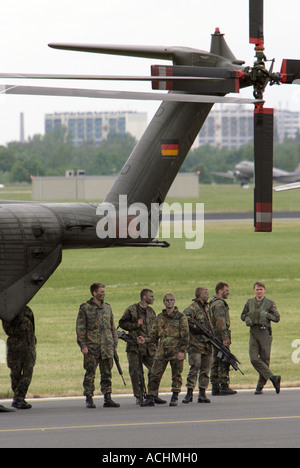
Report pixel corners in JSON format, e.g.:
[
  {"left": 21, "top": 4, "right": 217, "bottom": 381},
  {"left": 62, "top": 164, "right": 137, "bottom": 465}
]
[{"left": 182, "top": 287, "right": 212, "bottom": 403}]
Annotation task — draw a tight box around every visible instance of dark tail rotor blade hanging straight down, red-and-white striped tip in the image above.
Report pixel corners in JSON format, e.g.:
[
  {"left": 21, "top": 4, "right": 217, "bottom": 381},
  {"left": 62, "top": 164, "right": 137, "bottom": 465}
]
[{"left": 254, "top": 105, "right": 274, "bottom": 232}]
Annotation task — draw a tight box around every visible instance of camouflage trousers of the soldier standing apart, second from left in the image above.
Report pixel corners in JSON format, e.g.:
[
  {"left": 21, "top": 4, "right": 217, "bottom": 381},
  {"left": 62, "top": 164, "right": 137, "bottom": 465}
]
[{"left": 83, "top": 352, "right": 114, "bottom": 396}]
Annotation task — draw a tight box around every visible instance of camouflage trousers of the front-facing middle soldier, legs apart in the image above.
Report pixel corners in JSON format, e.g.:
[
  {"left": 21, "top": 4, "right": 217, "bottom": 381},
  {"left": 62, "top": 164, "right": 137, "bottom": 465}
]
[{"left": 148, "top": 358, "right": 183, "bottom": 396}]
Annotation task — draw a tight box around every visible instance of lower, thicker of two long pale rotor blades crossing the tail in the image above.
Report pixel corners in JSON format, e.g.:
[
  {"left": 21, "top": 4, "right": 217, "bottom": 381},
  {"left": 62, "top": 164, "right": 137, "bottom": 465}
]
[{"left": 0, "top": 84, "right": 264, "bottom": 104}]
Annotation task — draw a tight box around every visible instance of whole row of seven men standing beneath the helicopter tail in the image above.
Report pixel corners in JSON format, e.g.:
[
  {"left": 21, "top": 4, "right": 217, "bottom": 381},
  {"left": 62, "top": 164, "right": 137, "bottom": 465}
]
[{"left": 2, "top": 281, "right": 281, "bottom": 409}]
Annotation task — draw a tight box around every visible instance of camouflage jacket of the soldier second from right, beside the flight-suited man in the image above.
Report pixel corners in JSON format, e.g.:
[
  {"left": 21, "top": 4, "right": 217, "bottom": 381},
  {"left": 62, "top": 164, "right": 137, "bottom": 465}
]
[{"left": 209, "top": 296, "right": 231, "bottom": 345}]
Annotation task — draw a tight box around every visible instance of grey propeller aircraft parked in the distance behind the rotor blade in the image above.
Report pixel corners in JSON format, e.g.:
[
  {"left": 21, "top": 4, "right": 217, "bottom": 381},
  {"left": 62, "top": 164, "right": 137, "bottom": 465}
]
[{"left": 213, "top": 161, "right": 300, "bottom": 185}]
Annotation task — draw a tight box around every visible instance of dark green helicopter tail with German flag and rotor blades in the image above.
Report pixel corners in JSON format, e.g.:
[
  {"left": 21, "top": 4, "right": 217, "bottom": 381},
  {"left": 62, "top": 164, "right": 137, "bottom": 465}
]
[{"left": 0, "top": 0, "right": 300, "bottom": 321}]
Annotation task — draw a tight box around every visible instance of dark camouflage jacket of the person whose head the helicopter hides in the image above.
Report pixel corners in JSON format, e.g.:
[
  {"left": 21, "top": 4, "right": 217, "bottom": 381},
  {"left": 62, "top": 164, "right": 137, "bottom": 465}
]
[{"left": 2, "top": 306, "right": 36, "bottom": 347}]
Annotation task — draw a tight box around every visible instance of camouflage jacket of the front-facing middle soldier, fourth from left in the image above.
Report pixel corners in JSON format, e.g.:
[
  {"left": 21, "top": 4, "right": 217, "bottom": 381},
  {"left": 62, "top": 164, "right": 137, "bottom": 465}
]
[{"left": 146, "top": 307, "right": 189, "bottom": 360}]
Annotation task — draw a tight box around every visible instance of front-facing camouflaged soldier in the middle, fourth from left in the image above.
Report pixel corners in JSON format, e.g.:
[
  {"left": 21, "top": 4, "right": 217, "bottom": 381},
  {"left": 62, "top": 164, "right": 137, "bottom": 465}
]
[{"left": 138, "top": 293, "right": 189, "bottom": 406}]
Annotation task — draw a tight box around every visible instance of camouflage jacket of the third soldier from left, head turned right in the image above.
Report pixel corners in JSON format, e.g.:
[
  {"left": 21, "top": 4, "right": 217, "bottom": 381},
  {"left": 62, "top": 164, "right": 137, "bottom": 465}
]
[{"left": 119, "top": 304, "right": 156, "bottom": 356}]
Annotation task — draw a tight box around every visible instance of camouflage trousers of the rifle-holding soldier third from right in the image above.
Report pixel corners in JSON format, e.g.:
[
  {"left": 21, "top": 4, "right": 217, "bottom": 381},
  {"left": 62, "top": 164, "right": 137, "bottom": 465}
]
[{"left": 186, "top": 353, "right": 212, "bottom": 390}]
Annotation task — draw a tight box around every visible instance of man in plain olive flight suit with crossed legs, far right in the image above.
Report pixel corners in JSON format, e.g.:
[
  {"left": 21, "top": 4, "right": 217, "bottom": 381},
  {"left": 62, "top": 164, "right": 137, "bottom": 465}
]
[{"left": 241, "top": 281, "right": 281, "bottom": 395}]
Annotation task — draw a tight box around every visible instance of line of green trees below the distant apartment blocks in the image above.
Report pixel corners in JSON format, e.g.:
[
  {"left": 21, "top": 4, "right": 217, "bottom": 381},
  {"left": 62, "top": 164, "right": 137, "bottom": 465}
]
[{"left": 0, "top": 128, "right": 300, "bottom": 183}]
